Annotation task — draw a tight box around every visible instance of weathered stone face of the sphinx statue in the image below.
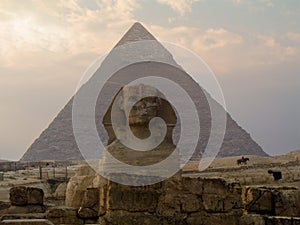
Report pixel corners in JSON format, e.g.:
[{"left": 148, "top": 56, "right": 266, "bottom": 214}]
[{"left": 122, "top": 85, "right": 161, "bottom": 125}]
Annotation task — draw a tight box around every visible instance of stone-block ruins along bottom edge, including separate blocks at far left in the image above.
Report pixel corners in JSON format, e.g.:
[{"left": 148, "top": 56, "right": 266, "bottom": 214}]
[{"left": 0, "top": 170, "right": 300, "bottom": 225}]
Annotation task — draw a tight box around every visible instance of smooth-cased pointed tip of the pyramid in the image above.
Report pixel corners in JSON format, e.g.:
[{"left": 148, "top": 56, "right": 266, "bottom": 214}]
[{"left": 115, "top": 22, "right": 156, "bottom": 47}]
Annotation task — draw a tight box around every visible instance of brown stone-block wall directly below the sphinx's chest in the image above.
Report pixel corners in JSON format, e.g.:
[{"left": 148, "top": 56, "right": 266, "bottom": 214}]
[{"left": 100, "top": 176, "right": 243, "bottom": 225}]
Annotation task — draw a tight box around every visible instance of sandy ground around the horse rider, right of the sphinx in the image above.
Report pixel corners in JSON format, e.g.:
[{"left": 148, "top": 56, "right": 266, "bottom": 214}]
[{"left": 183, "top": 150, "right": 300, "bottom": 188}]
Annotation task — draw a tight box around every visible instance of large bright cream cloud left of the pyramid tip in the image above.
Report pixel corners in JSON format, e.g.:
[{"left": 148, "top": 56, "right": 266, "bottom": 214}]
[{"left": 0, "top": 0, "right": 139, "bottom": 66}]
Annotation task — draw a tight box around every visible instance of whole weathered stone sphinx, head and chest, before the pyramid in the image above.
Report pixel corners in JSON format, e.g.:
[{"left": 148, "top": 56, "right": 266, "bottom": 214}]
[{"left": 101, "top": 84, "right": 180, "bottom": 176}]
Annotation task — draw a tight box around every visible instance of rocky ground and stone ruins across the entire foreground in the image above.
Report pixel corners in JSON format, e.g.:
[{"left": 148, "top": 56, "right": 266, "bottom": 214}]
[{"left": 0, "top": 150, "right": 300, "bottom": 225}]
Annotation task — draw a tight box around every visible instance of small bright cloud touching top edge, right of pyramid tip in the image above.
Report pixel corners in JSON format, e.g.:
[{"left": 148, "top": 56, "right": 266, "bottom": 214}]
[{"left": 157, "top": 0, "right": 200, "bottom": 16}]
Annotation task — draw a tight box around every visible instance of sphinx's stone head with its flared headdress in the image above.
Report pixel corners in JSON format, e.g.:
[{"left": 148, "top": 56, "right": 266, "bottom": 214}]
[{"left": 103, "top": 84, "right": 177, "bottom": 144}]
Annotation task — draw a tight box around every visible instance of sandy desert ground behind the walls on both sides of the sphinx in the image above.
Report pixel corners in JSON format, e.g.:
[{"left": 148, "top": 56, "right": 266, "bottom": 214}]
[{"left": 0, "top": 150, "right": 300, "bottom": 202}]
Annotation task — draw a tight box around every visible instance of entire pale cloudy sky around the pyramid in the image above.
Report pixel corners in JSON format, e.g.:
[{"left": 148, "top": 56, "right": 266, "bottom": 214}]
[{"left": 0, "top": 0, "right": 300, "bottom": 160}]
